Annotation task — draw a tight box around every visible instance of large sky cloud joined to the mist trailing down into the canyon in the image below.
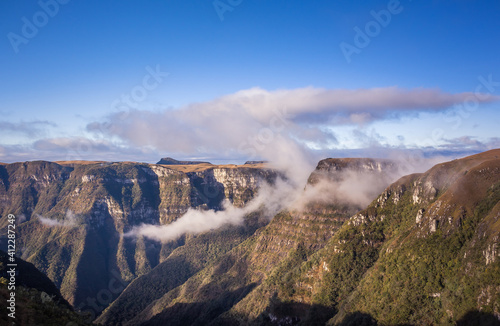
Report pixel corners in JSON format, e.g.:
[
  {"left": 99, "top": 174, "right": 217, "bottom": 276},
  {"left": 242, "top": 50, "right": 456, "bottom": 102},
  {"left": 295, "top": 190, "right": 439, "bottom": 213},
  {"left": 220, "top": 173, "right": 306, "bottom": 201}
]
[{"left": 34, "top": 87, "right": 498, "bottom": 241}]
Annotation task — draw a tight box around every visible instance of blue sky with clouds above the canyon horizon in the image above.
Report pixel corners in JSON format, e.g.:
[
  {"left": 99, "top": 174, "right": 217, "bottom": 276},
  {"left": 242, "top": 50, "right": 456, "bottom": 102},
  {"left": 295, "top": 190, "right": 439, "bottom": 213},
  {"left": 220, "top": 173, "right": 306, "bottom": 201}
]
[{"left": 0, "top": 0, "right": 500, "bottom": 162}]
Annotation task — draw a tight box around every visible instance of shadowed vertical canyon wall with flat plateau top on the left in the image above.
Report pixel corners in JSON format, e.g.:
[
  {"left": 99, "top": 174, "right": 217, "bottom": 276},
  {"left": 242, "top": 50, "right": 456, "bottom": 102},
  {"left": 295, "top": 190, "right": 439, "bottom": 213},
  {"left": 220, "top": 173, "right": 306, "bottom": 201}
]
[{"left": 0, "top": 162, "right": 277, "bottom": 312}]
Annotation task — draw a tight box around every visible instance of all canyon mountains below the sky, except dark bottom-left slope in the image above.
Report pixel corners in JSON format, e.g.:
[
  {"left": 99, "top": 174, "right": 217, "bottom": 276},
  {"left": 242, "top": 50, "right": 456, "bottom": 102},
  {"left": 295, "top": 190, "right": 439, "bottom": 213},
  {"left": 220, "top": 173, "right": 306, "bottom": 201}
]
[{"left": 0, "top": 150, "right": 500, "bottom": 325}]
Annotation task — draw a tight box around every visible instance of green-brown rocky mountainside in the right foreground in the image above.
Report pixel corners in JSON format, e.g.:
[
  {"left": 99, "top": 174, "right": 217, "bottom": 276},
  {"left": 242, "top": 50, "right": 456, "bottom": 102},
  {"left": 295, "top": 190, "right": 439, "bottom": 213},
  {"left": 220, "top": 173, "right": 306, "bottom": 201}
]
[{"left": 282, "top": 150, "right": 500, "bottom": 325}]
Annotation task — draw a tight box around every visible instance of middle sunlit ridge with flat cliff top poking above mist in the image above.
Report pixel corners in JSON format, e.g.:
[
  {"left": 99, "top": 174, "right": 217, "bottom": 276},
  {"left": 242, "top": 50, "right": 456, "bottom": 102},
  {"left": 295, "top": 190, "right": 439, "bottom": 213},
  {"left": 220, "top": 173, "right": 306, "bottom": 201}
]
[{"left": 114, "top": 159, "right": 393, "bottom": 325}]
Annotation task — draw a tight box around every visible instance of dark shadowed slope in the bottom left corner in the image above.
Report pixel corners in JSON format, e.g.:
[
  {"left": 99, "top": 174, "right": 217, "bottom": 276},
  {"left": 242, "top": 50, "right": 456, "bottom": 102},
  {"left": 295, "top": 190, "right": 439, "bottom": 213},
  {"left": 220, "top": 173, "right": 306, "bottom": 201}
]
[{"left": 0, "top": 250, "right": 90, "bottom": 326}]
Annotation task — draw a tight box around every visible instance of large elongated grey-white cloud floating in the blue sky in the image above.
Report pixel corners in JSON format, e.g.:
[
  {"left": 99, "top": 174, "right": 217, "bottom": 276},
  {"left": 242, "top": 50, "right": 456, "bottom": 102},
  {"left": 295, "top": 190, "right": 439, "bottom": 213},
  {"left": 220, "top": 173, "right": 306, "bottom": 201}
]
[{"left": 87, "top": 87, "right": 499, "bottom": 157}]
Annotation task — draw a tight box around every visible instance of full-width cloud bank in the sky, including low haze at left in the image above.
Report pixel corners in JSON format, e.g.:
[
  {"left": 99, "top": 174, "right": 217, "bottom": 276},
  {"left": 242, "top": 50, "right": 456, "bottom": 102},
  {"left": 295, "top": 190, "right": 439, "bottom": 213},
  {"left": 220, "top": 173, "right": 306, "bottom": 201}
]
[{"left": 0, "top": 86, "right": 500, "bottom": 165}]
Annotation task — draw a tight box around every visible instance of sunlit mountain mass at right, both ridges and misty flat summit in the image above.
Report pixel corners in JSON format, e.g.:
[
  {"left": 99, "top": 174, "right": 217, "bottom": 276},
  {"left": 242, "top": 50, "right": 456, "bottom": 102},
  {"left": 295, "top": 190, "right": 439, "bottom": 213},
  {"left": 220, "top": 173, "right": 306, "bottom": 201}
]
[{"left": 95, "top": 150, "right": 500, "bottom": 325}]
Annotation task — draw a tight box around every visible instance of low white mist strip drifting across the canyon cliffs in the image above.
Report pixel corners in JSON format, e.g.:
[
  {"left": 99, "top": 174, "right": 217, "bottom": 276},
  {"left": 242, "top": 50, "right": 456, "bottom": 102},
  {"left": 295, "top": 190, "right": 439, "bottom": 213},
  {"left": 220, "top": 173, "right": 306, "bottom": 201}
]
[{"left": 124, "top": 155, "right": 402, "bottom": 242}]
